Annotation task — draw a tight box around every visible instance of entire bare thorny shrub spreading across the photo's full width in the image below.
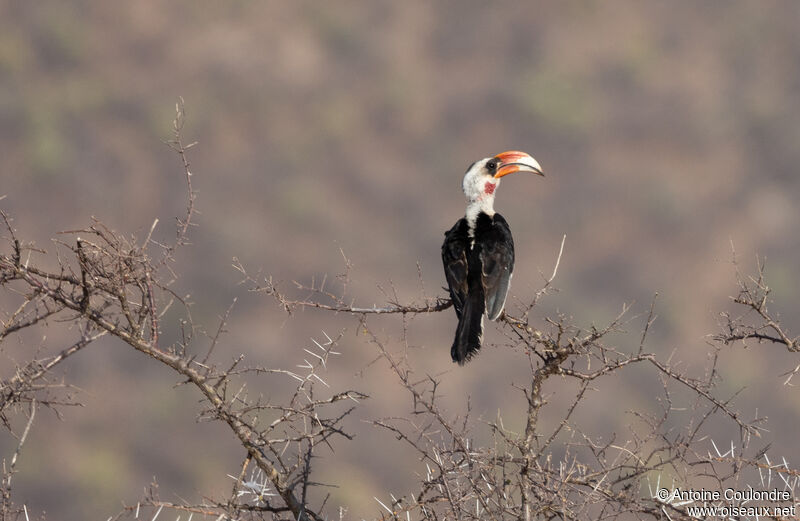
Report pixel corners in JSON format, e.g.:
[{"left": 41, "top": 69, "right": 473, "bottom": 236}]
[{"left": 0, "top": 103, "right": 800, "bottom": 520}]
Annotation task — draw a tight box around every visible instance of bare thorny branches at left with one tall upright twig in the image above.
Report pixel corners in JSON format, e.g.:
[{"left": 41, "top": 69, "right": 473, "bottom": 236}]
[{"left": 0, "top": 100, "right": 366, "bottom": 520}]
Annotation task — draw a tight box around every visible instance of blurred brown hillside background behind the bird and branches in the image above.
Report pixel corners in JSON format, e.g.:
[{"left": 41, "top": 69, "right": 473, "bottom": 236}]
[{"left": 0, "top": 0, "right": 800, "bottom": 520}]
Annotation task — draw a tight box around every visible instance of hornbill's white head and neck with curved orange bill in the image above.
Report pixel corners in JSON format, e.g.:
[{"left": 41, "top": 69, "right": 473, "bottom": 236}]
[{"left": 462, "top": 150, "right": 544, "bottom": 223}]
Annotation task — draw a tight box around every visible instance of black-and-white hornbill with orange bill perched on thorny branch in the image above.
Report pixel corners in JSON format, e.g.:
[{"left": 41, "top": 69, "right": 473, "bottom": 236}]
[{"left": 442, "top": 150, "right": 544, "bottom": 365}]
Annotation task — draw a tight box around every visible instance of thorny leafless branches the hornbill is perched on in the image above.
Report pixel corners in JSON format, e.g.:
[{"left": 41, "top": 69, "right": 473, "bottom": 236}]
[{"left": 248, "top": 237, "right": 798, "bottom": 520}]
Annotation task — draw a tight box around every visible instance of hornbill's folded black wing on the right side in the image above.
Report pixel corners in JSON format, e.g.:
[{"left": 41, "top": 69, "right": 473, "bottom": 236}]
[{"left": 480, "top": 213, "right": 514, "bottom": 320}]
